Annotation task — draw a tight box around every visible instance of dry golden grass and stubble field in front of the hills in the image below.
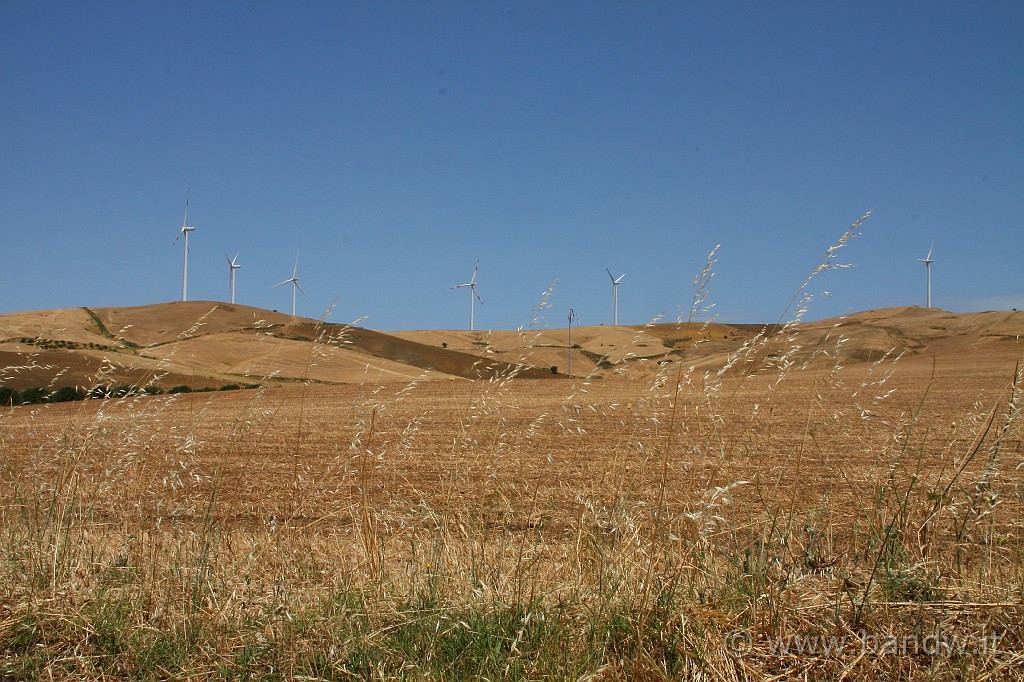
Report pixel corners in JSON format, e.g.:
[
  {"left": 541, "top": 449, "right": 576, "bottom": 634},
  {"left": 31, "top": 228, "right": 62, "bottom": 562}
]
[{"left": 0, "top": 216, "right": 1024, "bottom": 680}]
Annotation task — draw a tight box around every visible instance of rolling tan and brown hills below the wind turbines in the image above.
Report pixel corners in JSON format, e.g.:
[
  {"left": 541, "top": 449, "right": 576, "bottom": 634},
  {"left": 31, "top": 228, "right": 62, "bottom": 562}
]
[{"left": 0, "top": 301, "right": 1024, "bottom": 390}]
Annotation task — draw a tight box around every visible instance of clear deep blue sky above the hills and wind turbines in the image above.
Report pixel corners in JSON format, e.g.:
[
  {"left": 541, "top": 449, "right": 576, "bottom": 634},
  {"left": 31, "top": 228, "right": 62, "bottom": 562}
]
[{"left": 0, "top": 0, "right": 1024, "bottom": 330}]
